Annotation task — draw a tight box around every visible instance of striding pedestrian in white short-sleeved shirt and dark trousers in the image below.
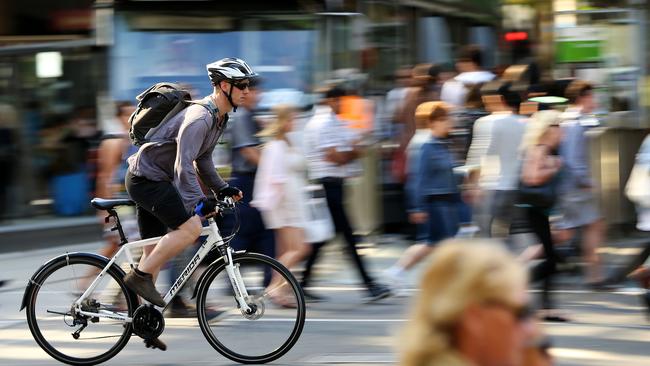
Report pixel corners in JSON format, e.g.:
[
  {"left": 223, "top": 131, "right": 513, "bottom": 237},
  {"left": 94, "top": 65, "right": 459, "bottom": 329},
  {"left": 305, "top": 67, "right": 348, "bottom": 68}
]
[{"left": 302, "top": 87, "right": 391, "bottom": 301}]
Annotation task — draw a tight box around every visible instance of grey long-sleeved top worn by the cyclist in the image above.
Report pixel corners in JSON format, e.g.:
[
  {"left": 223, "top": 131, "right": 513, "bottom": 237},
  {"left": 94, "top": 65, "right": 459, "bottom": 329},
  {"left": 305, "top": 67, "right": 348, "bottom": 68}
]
[{"left": 128, "top": 98, "right": 228, "bottom": 212}]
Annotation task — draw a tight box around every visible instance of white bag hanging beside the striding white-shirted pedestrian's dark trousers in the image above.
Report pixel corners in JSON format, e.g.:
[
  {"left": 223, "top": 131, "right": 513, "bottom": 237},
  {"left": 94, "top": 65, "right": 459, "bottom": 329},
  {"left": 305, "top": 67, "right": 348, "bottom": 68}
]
[{"left": 305, "top": 184, "right": 335, "bottom": 243}]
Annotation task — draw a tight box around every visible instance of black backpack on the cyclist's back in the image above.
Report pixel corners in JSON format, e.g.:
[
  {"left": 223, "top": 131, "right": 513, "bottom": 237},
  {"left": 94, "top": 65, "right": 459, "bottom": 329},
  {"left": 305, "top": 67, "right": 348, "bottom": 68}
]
[{"left": 129, "top": 83, "right": 216, "bottom": 146}]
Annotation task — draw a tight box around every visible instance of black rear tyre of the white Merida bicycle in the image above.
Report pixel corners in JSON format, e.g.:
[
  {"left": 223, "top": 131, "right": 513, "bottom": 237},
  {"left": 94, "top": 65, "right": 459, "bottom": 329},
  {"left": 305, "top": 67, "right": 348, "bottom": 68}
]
[{"left": 25, "top": 253, "right": 138, "bottom": 365}]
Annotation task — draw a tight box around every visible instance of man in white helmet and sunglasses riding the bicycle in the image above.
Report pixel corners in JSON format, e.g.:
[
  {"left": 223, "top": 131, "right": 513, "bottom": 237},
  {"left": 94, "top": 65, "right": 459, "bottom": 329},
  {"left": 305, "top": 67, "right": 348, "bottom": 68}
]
[{"left": 125, "top": 58, "right": 258, "bottom": 314}]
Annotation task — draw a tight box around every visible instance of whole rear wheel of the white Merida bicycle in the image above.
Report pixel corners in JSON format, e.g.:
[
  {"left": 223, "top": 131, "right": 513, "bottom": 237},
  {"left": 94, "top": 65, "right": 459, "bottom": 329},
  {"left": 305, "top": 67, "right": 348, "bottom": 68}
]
[{"left": 26, "top": 253, "right": 138, "bottom": 365}]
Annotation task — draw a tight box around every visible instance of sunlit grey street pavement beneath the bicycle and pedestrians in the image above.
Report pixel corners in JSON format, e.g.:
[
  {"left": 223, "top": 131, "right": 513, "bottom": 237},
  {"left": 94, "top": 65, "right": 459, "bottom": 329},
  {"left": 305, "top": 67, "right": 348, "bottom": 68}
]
[{"left": 0, "top": 235, "right": 650, "bottom": 366}]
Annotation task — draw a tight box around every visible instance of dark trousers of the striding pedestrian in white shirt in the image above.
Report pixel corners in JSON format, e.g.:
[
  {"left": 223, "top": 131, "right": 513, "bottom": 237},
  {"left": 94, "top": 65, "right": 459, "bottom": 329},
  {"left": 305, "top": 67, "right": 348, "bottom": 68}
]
[{"left": 302, "top": 178, "right": 374, "bottom": 287}]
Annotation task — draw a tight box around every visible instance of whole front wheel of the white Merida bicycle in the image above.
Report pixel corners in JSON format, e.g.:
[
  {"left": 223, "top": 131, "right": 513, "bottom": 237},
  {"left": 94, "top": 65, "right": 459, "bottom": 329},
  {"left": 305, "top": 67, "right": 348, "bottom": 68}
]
[{"left": 197, "top": 253, "right": 306, "bottom": 363}]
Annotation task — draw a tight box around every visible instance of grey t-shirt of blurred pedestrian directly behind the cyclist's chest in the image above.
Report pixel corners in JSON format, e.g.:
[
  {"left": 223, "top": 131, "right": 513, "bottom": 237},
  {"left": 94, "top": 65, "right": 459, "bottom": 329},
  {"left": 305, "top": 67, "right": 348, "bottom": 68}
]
[{"left": 230, "top": 108, "right": 261, "bottom": 173}]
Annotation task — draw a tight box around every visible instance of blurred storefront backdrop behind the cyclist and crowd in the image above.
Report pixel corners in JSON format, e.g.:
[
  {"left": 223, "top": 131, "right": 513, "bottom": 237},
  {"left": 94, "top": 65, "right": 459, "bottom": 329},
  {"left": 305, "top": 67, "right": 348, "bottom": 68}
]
[{"left": 0, "top": 0, "right": 650, "bottom": 232}]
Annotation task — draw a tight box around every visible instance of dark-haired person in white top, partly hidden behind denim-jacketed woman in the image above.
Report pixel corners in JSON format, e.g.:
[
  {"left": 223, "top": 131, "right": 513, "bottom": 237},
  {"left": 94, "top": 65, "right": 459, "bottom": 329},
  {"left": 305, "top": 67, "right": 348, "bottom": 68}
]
[{"left": 440, "top": 45, "right": 495, "bottom": 108}]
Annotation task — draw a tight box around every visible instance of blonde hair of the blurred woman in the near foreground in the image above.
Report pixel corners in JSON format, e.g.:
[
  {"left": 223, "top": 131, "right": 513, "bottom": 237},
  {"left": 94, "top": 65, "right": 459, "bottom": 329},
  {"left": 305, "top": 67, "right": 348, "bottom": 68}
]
[{"left": 400, "top": 239, "right": 527, "bottom": 366}]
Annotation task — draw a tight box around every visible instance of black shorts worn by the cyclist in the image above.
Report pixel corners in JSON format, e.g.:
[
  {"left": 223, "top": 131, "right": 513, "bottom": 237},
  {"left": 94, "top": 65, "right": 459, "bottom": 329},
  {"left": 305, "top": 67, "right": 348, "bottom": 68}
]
[{"left": 126, "top": 172, "right": 192, "bottom": 239}]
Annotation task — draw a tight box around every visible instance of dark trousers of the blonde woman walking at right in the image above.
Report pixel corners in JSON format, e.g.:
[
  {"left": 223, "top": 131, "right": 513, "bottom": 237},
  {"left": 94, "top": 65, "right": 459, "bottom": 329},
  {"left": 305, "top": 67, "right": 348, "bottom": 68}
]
[{"left": 527, "top": 207, "right": 558, "bottom": 309}]
